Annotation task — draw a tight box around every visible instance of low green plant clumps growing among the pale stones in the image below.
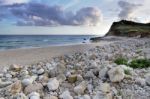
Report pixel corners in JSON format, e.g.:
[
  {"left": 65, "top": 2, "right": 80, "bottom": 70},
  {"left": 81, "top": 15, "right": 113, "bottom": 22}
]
[{"left": 114, "top": 57, "right": 150, "bottom": 68}]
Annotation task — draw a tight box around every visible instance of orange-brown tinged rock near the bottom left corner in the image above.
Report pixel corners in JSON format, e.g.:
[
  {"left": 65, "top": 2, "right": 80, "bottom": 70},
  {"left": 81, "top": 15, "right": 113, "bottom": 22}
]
[{"left": 10, "top": 81, "right": 22, "bottom": 95}]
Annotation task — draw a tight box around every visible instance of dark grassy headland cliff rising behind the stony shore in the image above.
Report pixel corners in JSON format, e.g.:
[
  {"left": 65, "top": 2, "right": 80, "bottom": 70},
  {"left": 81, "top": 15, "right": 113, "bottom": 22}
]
[{"left": 106, "top": 20, "right": 150, "bottom": 38}]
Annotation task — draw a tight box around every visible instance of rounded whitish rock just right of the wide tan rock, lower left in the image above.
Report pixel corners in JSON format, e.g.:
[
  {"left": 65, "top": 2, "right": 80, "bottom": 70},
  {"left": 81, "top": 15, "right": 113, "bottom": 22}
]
[{"left": 47, "top": 78, "right": 59, "bottom": 91}]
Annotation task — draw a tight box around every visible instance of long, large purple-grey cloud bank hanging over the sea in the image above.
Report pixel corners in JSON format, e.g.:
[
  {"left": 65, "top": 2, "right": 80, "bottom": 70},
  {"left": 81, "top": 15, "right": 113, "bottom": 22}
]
[{"left": 10, "top": 3, "right": 102, "bottom": 26}]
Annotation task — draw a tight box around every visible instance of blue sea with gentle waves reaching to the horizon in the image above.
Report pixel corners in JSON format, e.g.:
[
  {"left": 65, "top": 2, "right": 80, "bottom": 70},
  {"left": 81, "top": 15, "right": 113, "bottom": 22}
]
[{"left": 0, "top": 35, "right": 93, "bottom": 50}]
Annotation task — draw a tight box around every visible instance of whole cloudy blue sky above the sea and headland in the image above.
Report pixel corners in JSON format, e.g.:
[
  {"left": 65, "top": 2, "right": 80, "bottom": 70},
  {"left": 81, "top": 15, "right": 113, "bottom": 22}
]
[{"left": 0, "top": 0, "right": 150, "bottom": 35}]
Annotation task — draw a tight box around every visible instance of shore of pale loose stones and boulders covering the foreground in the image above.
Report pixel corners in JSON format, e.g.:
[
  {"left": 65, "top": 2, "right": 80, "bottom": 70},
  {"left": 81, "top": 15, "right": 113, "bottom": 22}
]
[{"left": 0, "top": 38, "right": 150, "bottom": 99}]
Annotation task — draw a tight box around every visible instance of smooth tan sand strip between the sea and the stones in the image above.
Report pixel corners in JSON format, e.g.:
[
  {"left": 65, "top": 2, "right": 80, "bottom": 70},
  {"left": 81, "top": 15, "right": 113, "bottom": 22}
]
[{"left": 0, "top": 41, "right": 108, "bottom": 70}]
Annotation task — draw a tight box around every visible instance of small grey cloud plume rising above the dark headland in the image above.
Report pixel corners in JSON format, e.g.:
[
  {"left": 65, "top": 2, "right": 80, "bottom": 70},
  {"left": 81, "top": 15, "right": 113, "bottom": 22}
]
[{"left": 118, "top": 1, "right": 142, "bottom": 20}]
